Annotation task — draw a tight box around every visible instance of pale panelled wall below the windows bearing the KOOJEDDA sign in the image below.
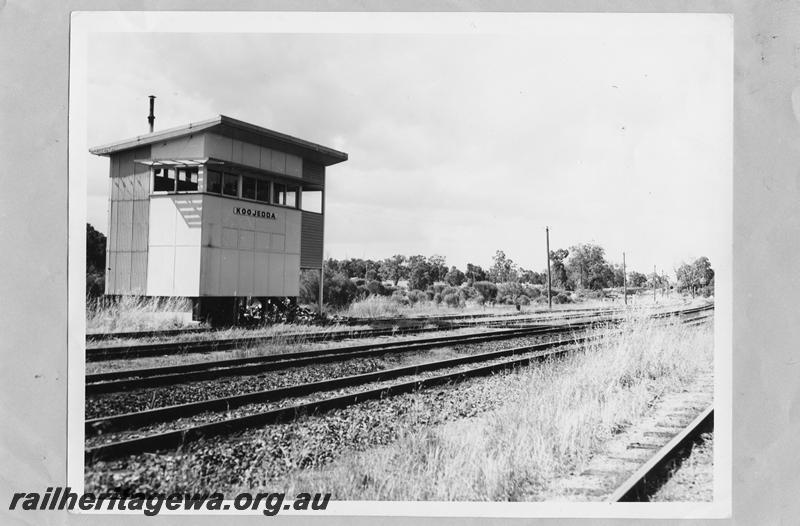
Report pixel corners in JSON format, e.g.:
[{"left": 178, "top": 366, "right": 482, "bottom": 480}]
[{"left": 200, "top": 194, "right": 301, "bottom": 297}]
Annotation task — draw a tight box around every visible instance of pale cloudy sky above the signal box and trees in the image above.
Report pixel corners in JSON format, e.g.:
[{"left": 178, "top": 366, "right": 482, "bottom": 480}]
[{"left": 81, "top": 14, "right": 733, "bottom": 273}]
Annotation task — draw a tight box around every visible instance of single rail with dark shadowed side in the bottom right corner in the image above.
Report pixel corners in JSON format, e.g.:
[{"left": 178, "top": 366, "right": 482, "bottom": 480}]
[{"left": 608, "top": 405, "right": 714, "bottom": 502}]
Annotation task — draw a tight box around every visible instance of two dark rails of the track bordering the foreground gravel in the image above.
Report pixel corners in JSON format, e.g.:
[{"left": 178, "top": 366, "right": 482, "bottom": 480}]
[{"left": 85, "top": 309, "right": 705, "bottom": 462}]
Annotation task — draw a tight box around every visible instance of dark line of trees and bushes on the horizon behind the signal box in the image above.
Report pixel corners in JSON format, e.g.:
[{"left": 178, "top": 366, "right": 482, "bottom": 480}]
[{"left": 86, "top": 223, "right": 714, "bottom": 306}]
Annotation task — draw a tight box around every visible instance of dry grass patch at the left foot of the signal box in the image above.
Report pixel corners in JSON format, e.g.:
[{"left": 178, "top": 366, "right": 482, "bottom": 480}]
[{"left": 86, "top": 296, "right": 196, "bottom": 333}]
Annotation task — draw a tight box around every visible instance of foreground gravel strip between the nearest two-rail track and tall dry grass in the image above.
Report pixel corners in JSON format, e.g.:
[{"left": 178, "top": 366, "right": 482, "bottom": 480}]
[{"left": 85, "top": 364, "right": 544, "bottom": 493}]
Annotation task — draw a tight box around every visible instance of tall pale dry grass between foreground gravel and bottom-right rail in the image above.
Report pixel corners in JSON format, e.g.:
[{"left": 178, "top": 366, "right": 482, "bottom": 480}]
[{"left": 270, "top": 319, "right": 713, "bottom": 501}]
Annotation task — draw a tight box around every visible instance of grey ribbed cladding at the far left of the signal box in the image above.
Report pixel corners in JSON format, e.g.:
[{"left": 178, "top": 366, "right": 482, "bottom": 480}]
[{"left": 106, "top": 146, "right": 150, "bottom": 294}]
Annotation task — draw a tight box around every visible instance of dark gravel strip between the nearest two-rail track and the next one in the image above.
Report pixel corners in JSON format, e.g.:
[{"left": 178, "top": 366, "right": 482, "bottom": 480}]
[{"left": 85, "top": 335, "right": 568, "bottom": 419}]
